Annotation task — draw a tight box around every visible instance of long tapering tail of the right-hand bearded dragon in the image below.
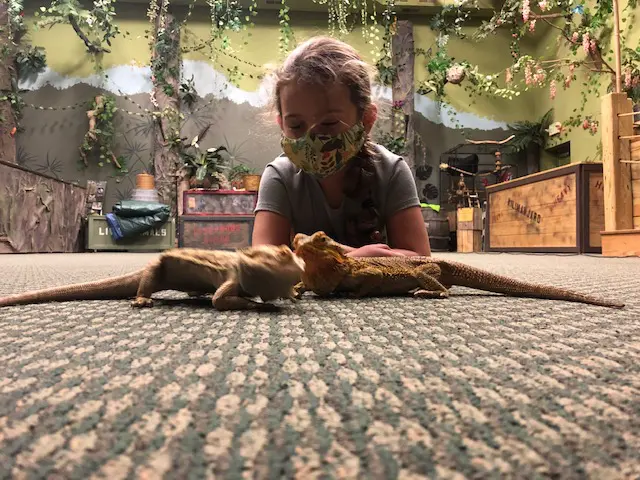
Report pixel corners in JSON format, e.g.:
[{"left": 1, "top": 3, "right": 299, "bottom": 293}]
[{"left": 440, "top": 262, "right": 624, "bottom": 308}]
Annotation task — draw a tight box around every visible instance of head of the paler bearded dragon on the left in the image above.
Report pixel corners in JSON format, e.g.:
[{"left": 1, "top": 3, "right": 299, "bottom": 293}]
[{"left": 237, "top": 245, "right": 305, "bottom": 302}]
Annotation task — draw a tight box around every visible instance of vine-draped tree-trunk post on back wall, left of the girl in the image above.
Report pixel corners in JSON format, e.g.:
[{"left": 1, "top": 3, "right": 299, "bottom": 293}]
[{"left": 153, "top": 6, "right": 181, "bottom": 217}]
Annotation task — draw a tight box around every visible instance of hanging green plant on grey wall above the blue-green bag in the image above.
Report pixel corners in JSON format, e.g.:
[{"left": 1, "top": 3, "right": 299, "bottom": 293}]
[{"left": 80, "top": 95, "right": 125, "bottom": 171}]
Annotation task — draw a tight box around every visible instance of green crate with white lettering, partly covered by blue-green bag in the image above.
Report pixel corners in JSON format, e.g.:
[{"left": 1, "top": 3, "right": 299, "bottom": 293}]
[{"left": 86, "top": 215, "right": 176, "bottom": 252}]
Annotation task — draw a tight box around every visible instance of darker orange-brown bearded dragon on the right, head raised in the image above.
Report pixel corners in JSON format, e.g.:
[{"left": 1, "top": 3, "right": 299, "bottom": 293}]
[{"left": 293, "top": 231, "right": 624, "bottom": 308}]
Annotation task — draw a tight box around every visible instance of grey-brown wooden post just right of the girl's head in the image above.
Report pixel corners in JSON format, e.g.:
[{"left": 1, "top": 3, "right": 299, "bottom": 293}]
[{"left": 391, "top": 20, "right": 416, "bottom": 170}]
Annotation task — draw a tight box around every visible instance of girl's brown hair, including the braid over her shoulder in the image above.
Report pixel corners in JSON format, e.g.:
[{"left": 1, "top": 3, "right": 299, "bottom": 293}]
[{"left": 272, "top": 36, "right": 382, "bottom": 247}]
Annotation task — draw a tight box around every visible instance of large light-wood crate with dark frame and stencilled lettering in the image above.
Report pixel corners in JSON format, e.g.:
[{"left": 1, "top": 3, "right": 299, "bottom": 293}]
[{"left": 486, "top": 163, "right": 604, "bottom": 253}]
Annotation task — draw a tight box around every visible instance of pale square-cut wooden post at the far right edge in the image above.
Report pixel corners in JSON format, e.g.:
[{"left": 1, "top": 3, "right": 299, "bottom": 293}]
[{"left": 601, "top": 93, "right": 633, "bottom": 232}]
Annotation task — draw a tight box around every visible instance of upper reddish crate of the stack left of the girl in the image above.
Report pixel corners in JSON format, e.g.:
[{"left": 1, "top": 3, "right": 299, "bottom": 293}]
[{"left": 182, "top": 189, "right": 258, "bottom": 215}]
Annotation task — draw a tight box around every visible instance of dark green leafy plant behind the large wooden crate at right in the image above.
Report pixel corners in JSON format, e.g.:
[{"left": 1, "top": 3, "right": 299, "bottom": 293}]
[{"left": 504, "top": 108, "right": 553, "bottom": 175}]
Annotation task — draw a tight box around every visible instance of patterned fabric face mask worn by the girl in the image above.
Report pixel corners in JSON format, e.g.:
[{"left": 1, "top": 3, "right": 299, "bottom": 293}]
[{"left": 280, "top": 122, "right": 367, "bottom": 178}]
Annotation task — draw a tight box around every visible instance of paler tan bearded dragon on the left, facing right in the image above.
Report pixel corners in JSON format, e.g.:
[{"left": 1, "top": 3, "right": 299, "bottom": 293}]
[{"left": 0, "top": 245, "right": 304, "bottom": 310}]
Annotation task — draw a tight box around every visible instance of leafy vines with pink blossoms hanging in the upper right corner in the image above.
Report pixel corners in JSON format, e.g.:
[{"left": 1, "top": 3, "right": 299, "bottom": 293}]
[{"left": 417, "top": 0, "right": 640, "bottom": 135}]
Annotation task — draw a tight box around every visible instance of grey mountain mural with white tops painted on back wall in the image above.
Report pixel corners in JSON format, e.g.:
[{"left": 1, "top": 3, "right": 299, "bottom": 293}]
[{"left": 17, "top": 60, "right": 507, "bottom": 211}]
